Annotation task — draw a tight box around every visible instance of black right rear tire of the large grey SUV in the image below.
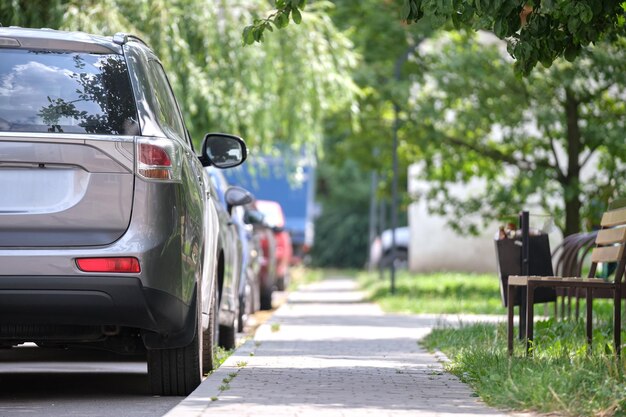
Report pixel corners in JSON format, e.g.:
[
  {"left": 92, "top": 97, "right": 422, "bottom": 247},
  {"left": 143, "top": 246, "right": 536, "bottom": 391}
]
[{"left": 147, "top": 290, "right": 202, "bottom": 396}]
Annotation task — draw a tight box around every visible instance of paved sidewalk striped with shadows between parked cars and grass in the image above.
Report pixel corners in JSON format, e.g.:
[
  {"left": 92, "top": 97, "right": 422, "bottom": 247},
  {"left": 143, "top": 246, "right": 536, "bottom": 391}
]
[{"left": 166, "top": 279, "right": 510, "bottom": 417}]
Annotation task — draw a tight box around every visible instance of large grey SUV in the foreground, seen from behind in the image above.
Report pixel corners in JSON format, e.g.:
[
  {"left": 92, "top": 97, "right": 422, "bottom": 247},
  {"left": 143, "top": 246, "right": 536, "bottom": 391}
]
[{"left": 0, "top": 28, "right": 246, "bottom": 395}]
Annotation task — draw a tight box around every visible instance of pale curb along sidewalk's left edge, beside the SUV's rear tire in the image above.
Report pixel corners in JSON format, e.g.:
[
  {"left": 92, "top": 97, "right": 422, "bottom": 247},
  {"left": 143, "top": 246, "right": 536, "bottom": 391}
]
[{"left": 163, "top": 339, "right": 256, "bottom": 417}]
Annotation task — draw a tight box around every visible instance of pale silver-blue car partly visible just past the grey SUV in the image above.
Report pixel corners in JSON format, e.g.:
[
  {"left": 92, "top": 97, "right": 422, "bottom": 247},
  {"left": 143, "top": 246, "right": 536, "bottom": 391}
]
[{"left": 206, "top": 167, "right": 253, "bottom": 349}]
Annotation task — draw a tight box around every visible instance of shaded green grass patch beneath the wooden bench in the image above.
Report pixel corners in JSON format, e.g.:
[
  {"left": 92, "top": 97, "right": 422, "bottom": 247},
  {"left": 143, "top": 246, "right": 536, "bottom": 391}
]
[{"left": 422, "top": 313, "right": 626, "bottom": 417}]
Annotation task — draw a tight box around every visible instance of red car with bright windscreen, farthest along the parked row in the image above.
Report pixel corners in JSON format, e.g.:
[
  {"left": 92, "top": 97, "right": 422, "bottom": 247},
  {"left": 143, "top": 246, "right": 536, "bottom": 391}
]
[{"left": 256, "top": 200, "right": 293, "bottom": 291}]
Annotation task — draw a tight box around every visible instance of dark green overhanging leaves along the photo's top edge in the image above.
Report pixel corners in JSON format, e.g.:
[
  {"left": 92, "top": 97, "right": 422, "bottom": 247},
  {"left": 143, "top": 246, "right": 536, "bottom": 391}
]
[{"left": 243, "top": 0, "right": 626, "bottom": 75}]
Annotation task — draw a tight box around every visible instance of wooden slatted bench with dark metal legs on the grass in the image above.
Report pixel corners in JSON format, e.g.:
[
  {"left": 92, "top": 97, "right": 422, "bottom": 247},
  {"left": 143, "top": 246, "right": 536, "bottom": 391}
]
[{"left": 507, "top": 207, "right": 626, "bottom": 356}]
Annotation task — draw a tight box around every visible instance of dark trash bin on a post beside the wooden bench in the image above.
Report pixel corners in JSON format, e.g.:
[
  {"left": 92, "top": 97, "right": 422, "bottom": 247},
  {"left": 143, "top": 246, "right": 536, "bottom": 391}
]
[{"left": 495, "top": 233, "right": 556, "bottom": 307}]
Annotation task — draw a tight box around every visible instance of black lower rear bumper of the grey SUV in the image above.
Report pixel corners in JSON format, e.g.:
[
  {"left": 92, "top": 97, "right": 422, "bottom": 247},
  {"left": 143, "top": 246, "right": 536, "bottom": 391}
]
[{"left": 0, "top": 276, "right": 195, "bottom": 344}]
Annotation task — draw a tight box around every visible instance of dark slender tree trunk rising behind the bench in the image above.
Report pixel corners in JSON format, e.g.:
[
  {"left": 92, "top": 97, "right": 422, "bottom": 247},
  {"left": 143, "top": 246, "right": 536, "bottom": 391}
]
[{"left": 563, "top": 88, "right": 582, "bottom": 236}]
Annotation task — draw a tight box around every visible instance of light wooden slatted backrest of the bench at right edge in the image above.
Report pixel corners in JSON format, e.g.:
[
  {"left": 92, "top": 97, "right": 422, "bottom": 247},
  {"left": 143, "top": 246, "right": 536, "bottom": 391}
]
[{"left": 589, "top": 207, "right": 626, "bottom": 283}]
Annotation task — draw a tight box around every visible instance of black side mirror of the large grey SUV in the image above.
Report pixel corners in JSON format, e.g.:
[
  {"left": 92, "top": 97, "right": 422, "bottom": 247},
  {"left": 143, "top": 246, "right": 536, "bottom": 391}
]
[{"left": 200, "top": 133, "right": 248, "bottom": 169}]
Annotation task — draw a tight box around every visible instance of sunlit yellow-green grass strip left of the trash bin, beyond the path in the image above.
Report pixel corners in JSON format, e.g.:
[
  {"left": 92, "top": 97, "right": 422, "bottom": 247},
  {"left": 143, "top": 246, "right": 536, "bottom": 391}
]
[{"left": 358, "top": 271, "right": 508, "bottom": 314}]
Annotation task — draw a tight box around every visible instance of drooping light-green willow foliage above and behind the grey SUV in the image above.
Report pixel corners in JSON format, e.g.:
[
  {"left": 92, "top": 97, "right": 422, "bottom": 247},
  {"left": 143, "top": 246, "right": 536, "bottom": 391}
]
[{"left": 0, "top": 0, "right": 357, "bottom": 151}]
